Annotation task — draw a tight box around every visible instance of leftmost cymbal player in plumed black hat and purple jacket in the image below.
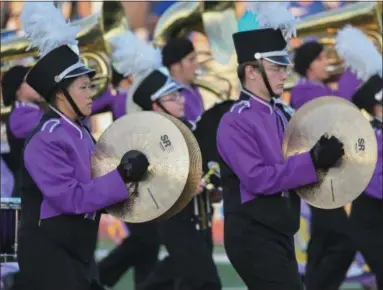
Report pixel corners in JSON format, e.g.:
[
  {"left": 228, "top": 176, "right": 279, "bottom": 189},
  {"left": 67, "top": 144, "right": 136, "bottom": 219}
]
[{"left": 18, "top": 2, "right": 148, "bottom": 290}]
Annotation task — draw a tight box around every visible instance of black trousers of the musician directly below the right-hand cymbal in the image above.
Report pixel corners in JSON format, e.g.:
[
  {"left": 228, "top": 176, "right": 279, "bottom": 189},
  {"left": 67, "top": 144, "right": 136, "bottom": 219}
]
[{"left": 305, "top": 207, "right": 356, "bottom": 290}]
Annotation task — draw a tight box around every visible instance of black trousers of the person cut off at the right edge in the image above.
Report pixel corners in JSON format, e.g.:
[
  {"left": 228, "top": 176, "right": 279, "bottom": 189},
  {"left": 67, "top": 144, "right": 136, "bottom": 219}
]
[{"left": 350, "top": 194, "right": 383, "bottom": 290}]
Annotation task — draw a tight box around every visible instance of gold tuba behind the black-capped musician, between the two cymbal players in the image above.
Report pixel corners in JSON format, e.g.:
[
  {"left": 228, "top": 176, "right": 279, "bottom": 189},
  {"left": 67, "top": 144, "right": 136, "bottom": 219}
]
[{"left": 154, "top": 1, "right": 239, "bottom": 109}]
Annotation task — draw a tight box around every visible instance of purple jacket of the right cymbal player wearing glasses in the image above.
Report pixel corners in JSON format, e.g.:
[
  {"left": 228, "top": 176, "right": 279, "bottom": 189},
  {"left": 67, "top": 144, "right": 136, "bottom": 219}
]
[{"left": 217, "top": 90, "right": 318, "bottom": 203}]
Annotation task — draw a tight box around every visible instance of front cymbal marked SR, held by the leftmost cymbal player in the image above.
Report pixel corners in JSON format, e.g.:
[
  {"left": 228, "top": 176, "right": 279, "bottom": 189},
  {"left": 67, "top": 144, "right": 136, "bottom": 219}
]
[{"left": 91, "top": 111, "right": 202, "bottom": 223}]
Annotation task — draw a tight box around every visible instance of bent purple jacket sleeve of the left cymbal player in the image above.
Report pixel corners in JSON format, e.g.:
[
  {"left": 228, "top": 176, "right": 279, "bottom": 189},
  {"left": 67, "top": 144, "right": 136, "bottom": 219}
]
[{"left": 24, "top": 132, "right": 128, "bottom": 214}]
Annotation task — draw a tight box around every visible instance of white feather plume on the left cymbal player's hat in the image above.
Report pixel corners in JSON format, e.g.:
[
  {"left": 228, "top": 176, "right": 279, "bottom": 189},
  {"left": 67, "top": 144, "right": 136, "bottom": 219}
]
[{"left": 20, "top": 1, "right": 81, "bottom": 57}]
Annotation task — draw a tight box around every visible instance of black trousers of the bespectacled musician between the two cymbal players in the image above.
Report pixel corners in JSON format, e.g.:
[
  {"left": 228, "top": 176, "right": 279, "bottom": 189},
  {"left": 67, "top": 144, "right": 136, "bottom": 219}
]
[{"left": 138, "top": 209, "right": 222, "bottom": 290}]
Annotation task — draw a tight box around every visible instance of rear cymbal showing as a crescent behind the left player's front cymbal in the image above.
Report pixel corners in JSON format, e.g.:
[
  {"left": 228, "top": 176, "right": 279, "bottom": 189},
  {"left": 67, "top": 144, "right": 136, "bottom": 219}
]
[{"left": 159, "top": 113, "right": 202, "bottom": 220}]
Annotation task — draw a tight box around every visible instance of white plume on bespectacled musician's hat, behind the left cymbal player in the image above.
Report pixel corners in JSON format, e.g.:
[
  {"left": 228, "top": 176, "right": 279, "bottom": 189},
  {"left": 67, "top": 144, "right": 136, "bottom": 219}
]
[{"left": 109, "top": 31, "right": 162, "bottom": 76}]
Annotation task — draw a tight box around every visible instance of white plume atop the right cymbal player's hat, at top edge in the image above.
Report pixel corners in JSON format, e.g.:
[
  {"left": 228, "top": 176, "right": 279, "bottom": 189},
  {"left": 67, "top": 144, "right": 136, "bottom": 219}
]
[{"left": 247, "top": 1, "right": 298, "bottom": 40}]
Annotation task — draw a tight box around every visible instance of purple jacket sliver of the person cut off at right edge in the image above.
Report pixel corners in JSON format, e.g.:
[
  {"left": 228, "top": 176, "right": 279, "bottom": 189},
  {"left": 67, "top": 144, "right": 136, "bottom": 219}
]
[{"left": 365, "top": 124, "right": 383, "bottom": 199}]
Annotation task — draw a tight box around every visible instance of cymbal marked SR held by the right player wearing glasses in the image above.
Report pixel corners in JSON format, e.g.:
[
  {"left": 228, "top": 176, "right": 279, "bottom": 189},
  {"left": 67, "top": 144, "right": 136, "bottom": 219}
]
[{"left": 282, "top": 96, "right": 377, "bottom": 209}]
